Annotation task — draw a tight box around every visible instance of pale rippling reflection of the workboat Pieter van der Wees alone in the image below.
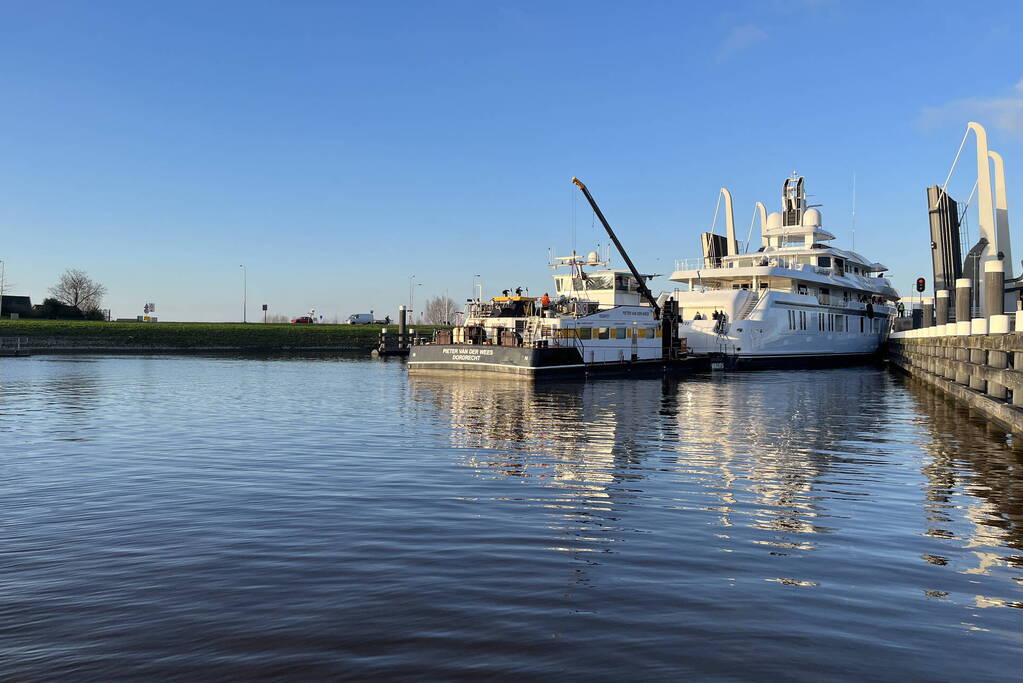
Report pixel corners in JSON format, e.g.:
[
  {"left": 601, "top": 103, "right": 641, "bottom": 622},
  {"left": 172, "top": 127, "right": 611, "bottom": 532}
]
[{"left": 410, "top": 375, "right": 664, "bottom": 561}]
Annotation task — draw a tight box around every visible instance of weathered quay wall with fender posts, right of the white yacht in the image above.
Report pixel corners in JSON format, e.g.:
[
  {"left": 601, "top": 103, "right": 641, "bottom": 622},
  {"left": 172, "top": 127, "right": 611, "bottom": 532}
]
[{"left": 888, "top": 330, "right": 1023, "bottom": 437}]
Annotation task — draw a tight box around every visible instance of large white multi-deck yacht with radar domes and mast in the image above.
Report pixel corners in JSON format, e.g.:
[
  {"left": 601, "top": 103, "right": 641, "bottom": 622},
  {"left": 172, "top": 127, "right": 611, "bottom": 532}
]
[{"left": 661, "top": 174, "right": 899, "bottom": 366}]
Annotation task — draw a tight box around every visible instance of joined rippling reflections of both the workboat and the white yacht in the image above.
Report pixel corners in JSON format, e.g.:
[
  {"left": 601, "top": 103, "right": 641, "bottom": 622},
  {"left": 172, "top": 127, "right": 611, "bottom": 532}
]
[{"left": 410, "top": 371, "right": 885, "bottom": 568}]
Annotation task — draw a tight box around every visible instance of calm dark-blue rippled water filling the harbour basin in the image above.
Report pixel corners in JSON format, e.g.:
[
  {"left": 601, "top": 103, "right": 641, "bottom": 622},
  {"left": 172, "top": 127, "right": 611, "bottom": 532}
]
[{"left": 0, "top": 357, "right": 1023, "bottom": 680}]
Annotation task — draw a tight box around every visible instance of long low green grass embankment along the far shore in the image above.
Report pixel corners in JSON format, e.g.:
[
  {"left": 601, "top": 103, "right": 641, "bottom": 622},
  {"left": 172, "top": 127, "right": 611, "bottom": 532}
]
[{"left": 0, "top": 320, "right": 448, "bottom": 351}]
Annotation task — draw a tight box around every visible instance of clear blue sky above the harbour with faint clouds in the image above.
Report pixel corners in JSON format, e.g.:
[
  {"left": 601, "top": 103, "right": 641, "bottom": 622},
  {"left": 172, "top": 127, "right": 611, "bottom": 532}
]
[{"left": 0, "top": 0, "right": 1023, "bottom": 320}]
